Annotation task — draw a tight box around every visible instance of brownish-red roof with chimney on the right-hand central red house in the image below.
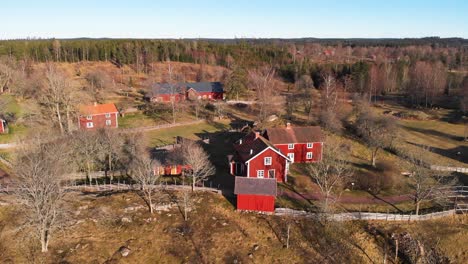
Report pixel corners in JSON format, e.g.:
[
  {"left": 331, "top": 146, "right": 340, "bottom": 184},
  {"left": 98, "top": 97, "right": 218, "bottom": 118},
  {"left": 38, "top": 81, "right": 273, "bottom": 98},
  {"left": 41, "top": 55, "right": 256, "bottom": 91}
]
[{"left": 263, "top": 126, "right": 323, "bottom": 144}]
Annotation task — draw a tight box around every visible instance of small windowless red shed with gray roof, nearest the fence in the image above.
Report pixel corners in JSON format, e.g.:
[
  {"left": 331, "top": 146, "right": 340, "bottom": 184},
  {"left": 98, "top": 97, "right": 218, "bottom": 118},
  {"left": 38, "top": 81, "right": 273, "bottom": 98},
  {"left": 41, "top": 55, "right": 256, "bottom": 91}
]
[{"left": 234, "top": 177, "right": 276, "bottom": 212}]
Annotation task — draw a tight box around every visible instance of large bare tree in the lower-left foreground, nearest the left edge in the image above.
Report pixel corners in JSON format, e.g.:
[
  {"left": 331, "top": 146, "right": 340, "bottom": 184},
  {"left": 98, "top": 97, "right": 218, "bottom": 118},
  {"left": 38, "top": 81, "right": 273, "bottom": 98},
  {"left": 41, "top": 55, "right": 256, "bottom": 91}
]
[{"left": 15, "top": 140, "right": 70, "bottom": 252}]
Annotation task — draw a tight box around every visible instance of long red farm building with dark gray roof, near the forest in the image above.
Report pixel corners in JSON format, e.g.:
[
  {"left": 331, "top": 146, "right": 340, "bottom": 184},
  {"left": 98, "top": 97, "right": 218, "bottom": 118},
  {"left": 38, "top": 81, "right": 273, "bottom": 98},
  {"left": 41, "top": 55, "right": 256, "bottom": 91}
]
[{"left": 146, "top": 82, "right": 224, "bottom": 102}]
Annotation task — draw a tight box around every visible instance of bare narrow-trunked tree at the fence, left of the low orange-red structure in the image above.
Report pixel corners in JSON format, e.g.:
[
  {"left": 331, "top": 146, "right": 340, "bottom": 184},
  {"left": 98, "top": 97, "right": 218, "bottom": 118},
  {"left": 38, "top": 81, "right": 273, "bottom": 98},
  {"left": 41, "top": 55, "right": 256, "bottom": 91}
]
[{"left": 129, "top": 156, "right": 159, "bottom": 213}]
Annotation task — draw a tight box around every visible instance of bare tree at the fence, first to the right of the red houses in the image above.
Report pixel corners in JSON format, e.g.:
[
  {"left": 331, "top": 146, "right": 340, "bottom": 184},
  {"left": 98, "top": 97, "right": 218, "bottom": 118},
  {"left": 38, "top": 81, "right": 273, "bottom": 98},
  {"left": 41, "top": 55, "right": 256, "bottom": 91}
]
[{"left": 307, "top": 142, "right": 352, "bottom": 213}]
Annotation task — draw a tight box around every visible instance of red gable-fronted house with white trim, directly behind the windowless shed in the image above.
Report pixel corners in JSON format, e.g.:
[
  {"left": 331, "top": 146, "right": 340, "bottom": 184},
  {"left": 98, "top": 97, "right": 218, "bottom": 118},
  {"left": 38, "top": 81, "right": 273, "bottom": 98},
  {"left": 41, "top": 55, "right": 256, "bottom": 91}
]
[{"left": 230, "top": 132, "right": 290, "bottom": 182}]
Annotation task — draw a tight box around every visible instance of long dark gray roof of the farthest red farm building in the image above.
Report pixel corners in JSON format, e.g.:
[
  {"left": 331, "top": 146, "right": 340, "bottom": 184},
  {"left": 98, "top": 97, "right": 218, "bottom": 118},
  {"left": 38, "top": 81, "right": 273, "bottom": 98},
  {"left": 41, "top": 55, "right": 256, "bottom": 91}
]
[{"left": 148, "top": 82, "right": 224, "bottom": 96}]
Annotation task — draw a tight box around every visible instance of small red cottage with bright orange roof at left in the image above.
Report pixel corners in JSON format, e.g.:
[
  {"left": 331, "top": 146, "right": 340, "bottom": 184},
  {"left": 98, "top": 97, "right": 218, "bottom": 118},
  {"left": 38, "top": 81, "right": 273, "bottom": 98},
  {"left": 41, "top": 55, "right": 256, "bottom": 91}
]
[{"left": 78, "top": 103, "right": 119, "bottom": 130}]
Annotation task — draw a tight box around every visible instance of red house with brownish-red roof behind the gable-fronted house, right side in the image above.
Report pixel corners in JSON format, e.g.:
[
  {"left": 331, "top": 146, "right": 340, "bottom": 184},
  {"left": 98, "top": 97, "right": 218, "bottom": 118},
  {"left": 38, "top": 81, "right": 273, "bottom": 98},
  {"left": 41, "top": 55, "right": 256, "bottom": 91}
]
[{"left": 262, "top": 123, "right": 323, "bottom": 163}]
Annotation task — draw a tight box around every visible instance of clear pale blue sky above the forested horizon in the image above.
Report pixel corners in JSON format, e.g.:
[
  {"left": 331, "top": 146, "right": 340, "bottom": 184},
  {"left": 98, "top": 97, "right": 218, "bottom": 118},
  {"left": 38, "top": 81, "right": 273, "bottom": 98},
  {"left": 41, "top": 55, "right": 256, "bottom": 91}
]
[{"left": 0, "top": 0, "right": 468, "bottom": 39}]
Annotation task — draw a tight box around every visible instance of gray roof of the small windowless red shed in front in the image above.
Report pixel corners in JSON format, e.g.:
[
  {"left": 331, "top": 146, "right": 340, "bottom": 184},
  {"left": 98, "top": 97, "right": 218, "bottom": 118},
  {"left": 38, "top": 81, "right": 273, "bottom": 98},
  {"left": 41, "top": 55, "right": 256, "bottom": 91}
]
[{"left": 234, "top": 176, "right": 276, "bottom": 196}]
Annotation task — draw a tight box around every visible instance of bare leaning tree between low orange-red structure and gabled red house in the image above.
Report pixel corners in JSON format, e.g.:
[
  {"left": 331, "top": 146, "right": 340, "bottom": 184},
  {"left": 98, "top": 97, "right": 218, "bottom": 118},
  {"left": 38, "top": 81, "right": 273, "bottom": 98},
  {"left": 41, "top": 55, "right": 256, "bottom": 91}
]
[{"left": 180, "top": 140, "right": 215, "bottom": 191}]
